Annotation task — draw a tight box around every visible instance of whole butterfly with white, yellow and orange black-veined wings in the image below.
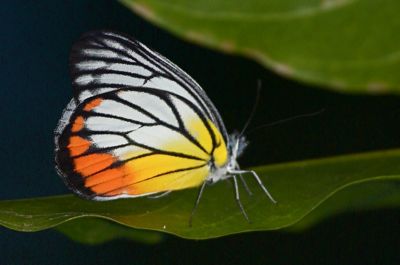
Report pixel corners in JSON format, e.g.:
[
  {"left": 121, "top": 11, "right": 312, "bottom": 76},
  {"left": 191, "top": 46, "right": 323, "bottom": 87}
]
[{"left": 55, "top": 31, "right": 274, "bottom": 220}]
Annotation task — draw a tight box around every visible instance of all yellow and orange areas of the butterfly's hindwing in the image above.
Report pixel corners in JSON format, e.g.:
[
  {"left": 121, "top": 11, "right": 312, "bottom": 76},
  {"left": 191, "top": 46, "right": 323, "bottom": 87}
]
[{"left": 67, "top": 100, "right": 228, "bottom": 197}]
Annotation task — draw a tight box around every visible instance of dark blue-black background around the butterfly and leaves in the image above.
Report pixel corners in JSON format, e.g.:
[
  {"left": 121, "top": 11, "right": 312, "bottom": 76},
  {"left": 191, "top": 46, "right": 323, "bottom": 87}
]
[{"left": 0, "top": 0, "right": 400, "bottom": 264}]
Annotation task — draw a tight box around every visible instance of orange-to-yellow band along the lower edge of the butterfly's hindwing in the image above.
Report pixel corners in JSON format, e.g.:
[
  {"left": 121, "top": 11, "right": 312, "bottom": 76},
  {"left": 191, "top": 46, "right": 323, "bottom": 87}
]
[{"left": 73, "top": 153, "right": 209, "bottom": 197}]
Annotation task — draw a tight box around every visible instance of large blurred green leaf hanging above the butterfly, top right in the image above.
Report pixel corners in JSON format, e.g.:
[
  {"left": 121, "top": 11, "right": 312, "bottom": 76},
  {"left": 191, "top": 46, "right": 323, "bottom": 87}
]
[{"left": 121, "top": 0, "right": 400, "bottom": 92}]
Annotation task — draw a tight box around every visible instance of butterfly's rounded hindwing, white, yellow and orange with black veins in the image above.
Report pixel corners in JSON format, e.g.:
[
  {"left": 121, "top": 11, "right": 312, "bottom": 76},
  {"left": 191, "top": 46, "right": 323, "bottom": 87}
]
[{"left": 56, "top": 89, "right": 226, "bottom": 199}]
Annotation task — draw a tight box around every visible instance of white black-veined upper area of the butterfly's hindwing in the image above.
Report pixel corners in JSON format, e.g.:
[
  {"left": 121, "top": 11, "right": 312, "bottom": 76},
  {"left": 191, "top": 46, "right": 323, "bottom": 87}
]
[{"left": 76, "top": 86, "right": 211, "bottom": 160}]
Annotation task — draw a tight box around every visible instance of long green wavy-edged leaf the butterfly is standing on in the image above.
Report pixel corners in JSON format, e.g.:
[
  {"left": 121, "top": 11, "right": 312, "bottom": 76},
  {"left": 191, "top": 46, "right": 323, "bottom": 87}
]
[{"left": 0, "top": 150, "right": 400, "bottom": 239}]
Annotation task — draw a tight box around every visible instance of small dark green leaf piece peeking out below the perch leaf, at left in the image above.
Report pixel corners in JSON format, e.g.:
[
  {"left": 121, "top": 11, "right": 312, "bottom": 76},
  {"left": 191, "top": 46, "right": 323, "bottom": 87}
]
[{"left": 55, "top": 218, "right": 163, "bottom": 245}]
